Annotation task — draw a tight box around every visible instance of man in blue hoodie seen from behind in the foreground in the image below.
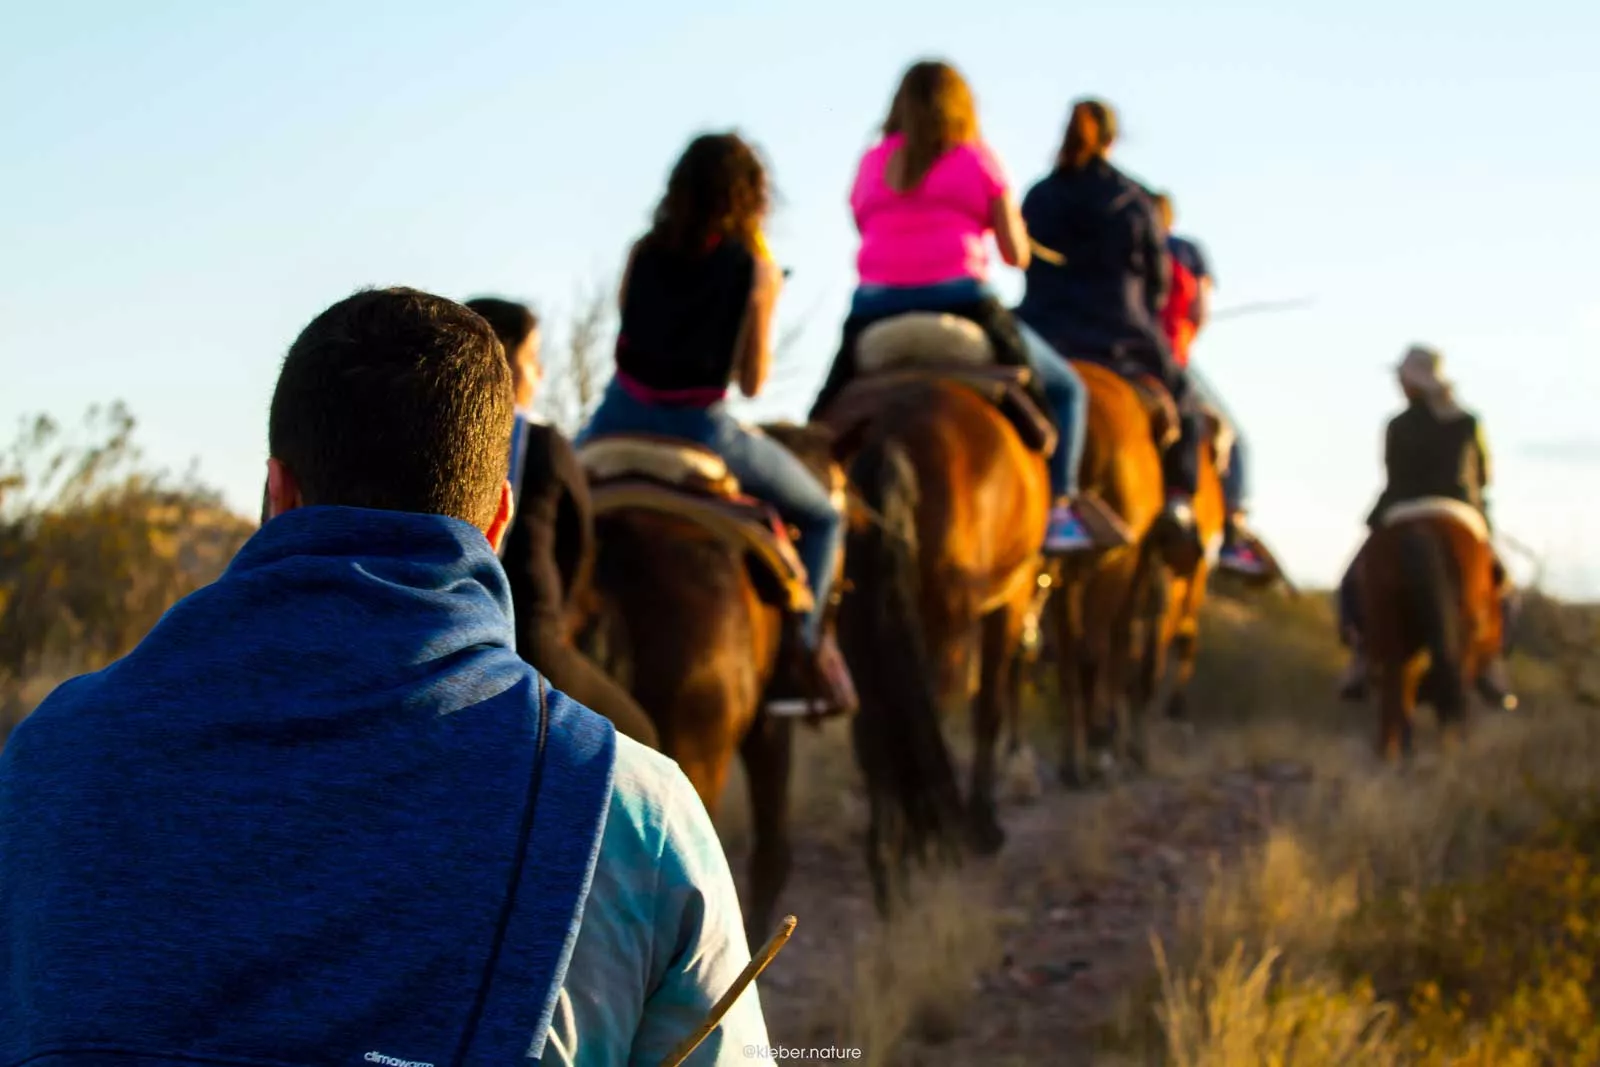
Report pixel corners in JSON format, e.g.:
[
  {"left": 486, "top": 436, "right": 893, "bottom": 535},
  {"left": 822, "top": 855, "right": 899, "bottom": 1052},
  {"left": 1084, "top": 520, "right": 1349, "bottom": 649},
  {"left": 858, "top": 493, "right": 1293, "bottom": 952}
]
[{"left": 0, "top": 290, "right": 766, "bottom": 1067}]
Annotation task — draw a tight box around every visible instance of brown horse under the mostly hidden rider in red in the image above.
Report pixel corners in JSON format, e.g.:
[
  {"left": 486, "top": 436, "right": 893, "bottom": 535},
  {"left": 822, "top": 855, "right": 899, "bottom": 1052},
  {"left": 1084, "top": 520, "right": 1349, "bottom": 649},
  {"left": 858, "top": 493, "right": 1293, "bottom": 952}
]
[{"left": 1134, "top": 412, "right": 1226, "bottom": 734}]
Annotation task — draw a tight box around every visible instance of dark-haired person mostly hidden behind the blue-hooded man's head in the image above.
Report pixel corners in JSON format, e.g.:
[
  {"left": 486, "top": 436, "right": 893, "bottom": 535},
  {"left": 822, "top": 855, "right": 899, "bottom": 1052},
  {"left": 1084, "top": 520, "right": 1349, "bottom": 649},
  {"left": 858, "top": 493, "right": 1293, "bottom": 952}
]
[{"left": 467, "top": 298, "right": 658, "bottom": 749}]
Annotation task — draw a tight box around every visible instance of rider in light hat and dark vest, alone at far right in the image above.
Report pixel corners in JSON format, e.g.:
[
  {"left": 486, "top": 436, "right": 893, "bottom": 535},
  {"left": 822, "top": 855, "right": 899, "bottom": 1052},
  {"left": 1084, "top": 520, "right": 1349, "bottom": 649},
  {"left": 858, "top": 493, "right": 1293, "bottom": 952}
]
[{"left": 1338, "top": 346, "right": 1515, "bottom": 707}]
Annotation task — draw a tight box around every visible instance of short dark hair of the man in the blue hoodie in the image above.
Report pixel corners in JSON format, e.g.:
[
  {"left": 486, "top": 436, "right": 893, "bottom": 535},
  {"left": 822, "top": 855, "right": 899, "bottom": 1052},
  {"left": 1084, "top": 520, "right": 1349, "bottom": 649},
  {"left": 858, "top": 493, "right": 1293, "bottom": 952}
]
[{"left": 267, "top": 288, "right": 514, "bottom": 528}]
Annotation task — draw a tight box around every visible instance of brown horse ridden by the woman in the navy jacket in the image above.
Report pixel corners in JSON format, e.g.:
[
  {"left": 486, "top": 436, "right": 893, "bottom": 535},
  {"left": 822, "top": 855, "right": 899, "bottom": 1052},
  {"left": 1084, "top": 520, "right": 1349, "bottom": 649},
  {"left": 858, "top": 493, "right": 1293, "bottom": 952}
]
[{"left": 1048, "top": 360, "right": 1165, "bottom": 787}]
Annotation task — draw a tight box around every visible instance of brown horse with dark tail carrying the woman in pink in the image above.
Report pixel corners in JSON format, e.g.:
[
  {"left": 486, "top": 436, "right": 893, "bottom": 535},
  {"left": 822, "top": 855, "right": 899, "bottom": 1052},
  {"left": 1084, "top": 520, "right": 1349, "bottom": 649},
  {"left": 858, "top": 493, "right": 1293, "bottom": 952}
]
[{"left": 821, "top": 366, "right": 1050, "bottom": 913}]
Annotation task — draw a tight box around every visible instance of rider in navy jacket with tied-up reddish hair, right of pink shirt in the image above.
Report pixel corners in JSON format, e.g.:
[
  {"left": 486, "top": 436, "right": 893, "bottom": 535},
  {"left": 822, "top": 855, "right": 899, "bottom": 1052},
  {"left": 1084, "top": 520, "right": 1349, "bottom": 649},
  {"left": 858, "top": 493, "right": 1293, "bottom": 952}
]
[{"left": 1016, "top": 99, "right": 1202, "bottom": 530}]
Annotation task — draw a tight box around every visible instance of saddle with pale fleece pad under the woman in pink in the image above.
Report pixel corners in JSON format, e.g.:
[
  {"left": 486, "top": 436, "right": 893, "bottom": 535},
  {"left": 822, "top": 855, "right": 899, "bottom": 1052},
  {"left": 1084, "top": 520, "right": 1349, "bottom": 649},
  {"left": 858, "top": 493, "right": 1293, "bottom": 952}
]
[{"left": 821, "top": 312, "right": 1056, "bottom": 456}]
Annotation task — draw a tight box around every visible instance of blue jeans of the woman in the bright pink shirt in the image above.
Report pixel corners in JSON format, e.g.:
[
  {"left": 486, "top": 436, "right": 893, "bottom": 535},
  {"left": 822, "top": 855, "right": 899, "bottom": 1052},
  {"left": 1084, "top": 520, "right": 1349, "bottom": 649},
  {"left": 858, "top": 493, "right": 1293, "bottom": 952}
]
[{"left": 850, "top": 278, "right": 1088, "bottom": 499}]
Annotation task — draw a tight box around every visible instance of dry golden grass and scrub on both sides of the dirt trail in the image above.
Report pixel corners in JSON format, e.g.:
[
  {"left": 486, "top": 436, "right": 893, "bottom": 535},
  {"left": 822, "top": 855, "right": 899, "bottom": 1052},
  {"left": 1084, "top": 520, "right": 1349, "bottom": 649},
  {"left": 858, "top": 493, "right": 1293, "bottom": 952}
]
[{"left": 0, "top": 410, "right": 1600, "bottom": 1067}]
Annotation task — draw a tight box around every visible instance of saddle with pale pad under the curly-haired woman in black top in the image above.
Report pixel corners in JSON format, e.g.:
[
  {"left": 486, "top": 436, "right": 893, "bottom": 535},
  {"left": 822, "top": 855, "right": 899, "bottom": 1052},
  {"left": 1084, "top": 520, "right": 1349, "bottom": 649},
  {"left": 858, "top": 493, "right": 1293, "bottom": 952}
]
[{"left": 578, "top": 434, "right": 813, "bottom": 614}]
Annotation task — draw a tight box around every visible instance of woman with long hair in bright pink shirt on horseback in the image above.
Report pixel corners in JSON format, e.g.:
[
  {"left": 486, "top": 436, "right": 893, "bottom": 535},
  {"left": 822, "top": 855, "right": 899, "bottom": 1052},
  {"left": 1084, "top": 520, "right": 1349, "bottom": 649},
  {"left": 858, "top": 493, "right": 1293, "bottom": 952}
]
[{"left": 813, "top": 62, "right": 1120, "bottom": 553}]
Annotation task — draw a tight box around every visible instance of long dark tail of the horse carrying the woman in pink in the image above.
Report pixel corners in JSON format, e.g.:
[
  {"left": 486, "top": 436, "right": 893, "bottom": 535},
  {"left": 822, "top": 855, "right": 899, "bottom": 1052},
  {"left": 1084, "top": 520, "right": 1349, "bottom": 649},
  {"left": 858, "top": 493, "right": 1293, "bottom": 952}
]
[{"left": 838, "top": 434, "right": 962, "bottom": 859}]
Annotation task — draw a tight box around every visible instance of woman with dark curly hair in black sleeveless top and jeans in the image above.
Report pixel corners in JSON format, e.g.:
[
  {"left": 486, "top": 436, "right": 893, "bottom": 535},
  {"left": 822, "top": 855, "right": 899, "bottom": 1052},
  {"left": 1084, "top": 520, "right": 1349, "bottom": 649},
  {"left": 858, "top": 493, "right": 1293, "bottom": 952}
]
[{"left": 579, "top": 133, "right": 853, "bottom": 712}]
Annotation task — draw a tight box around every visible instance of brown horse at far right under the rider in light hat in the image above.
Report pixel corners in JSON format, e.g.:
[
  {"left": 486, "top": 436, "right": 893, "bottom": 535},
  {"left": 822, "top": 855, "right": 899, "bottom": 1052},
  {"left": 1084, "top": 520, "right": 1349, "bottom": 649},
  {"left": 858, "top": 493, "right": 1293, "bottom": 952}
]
[{"left": 1358, "top": 501, "right": 1501, "bottom": 761}]
